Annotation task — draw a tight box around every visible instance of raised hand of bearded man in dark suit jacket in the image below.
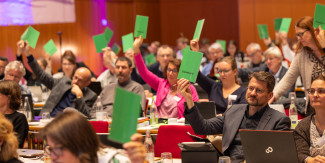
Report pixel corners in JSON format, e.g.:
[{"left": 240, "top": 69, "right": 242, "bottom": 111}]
[{"left": 177, "top": 78, "right": 194, "bottom": 109}]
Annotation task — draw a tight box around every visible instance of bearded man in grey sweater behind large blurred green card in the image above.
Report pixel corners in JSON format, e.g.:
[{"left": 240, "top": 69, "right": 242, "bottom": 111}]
[{"left": 91, "top": 57, "right": 146, "bottom": 118}]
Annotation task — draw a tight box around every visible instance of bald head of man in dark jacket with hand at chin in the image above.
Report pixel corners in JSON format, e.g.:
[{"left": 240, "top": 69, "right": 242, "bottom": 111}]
[{"left": 71, "top": 67, "right": 91, "bottom": 89}]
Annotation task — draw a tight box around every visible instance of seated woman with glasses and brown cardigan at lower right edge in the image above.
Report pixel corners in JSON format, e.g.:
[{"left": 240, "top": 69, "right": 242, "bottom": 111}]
[{"left": 294, "top": 75, "right": 325, "bottom": 163}]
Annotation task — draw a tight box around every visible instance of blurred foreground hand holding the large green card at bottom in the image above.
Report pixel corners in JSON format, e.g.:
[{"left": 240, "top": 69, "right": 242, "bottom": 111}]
[{"left": 123, "top": 133, "right": 147, "bottom": 163}]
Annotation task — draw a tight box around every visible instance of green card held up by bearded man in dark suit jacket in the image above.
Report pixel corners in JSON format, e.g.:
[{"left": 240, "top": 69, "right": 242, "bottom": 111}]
[{"left": 177, "top": 50, "right": 203, "bottom": 82}]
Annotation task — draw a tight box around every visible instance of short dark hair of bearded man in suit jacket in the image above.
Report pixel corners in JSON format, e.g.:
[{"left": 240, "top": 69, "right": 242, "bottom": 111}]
[{"left": 249, "top": 71, "right": 275, "bottom": 92}]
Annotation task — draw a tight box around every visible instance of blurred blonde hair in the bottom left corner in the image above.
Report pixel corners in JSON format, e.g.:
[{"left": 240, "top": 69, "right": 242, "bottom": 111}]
[{"left": 0, "top": 113, "right": 18, "bottom": 162}]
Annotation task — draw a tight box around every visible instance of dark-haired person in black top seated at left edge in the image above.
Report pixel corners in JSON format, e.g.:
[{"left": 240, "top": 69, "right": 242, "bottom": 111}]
[{"left": 0, "top": 81, "right": 29, "bottom": 148}]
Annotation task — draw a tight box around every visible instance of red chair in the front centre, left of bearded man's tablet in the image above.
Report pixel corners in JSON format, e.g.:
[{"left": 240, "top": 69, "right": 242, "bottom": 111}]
[{"left": 155, "top": 125, "right": 206, "bottom": 158}]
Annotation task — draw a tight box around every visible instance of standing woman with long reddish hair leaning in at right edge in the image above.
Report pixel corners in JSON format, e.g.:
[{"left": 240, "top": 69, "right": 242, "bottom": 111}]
[{"left": 270, "top": 16, "right": 325, "bottom": 115}]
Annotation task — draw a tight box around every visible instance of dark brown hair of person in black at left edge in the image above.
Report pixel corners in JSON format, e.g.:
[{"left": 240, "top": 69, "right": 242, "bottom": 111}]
[{"left": 0, "top": 80, "right": 21, "bottom": 110}]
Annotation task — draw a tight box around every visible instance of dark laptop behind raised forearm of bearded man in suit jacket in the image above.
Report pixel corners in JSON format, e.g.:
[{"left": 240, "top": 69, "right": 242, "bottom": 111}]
[{"left": 184, "top": 101, "right": 216, "bottom": 124}]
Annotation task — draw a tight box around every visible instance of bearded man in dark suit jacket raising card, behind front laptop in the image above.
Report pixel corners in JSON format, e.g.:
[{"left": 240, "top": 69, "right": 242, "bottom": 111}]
[{"left": 177, "top": 71, "right": 290, "bottom": 162}]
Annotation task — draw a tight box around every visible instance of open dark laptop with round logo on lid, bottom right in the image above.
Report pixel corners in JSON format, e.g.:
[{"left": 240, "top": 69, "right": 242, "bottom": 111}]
[{"left": 239, "top": 129, "right": 298, "bottom": 163}]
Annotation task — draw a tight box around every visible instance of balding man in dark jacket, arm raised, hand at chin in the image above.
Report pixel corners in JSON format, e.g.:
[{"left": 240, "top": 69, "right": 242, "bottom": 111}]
[{"left": 18, "top": 41, "right": 97, "bottom": 117}]
